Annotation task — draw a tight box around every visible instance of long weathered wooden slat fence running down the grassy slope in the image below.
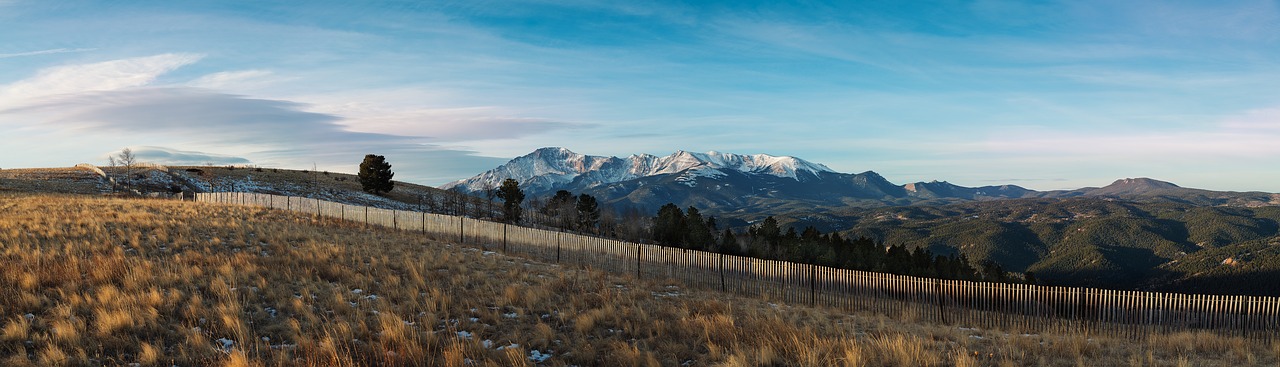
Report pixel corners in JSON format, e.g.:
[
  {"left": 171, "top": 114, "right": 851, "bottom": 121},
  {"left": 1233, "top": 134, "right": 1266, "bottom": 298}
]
[{"left": 196, "top": 193, "right": 1280, "bottom": 341}]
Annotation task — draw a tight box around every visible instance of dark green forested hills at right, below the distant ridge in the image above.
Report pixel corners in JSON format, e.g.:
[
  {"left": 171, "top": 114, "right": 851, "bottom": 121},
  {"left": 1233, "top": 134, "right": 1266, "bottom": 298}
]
[{"left": 842, "top": 198, "right": 1280, "bottom": 293}]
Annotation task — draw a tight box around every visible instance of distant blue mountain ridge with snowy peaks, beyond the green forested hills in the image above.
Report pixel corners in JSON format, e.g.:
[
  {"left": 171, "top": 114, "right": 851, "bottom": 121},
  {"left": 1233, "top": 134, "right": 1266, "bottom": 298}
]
[{"left": 443, "top": 147, "right": 1280, "bottom": 219}]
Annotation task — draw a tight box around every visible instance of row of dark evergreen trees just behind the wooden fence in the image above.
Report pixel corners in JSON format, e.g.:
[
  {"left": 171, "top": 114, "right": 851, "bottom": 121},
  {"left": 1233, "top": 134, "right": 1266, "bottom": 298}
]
[{"left": 404, "top": 175, "right": 1013, "bottom": 283}]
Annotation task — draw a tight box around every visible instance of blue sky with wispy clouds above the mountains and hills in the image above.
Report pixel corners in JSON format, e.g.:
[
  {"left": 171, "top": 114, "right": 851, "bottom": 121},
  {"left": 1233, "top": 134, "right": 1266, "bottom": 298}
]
[{"left": 0, "top": 0, "right": 1280, "bottom": 192}]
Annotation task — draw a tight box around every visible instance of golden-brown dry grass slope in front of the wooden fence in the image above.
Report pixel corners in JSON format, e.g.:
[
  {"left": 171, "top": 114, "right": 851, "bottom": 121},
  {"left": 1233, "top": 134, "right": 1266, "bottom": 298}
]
[{"left": 0, "top": 196, "right": 1280, "bottom": 366}]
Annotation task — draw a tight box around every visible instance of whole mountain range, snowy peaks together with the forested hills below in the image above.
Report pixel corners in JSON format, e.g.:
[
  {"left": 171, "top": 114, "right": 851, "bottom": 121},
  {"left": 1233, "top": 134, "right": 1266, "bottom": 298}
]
[{"left": 444, "top": 148, "right": 1280, "bottom": 294}]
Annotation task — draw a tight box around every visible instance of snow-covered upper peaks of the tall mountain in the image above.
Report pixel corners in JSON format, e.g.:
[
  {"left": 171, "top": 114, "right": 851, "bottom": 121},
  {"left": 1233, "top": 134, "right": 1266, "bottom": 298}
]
[{"left": 444, "top": 147, "right": 835, "bottom": 192}]
